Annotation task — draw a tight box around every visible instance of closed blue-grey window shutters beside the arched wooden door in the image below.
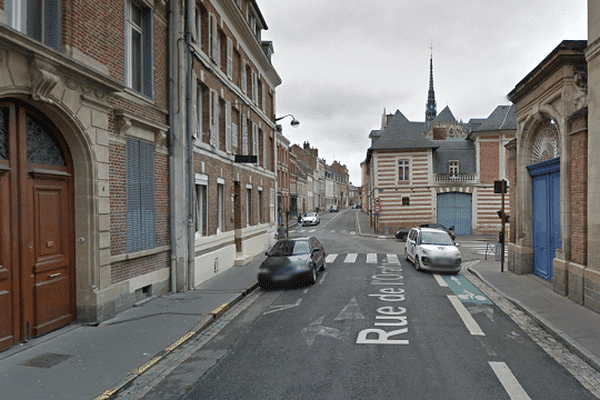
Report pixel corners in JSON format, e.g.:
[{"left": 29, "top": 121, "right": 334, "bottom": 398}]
[{"left": 126, "top": 138, "right": 156, "bottom": 253}]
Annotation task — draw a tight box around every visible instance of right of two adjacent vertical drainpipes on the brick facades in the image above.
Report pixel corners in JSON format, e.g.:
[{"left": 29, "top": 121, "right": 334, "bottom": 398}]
[{"left": 185, "top": 0, "right": 196, "bottom": 290}]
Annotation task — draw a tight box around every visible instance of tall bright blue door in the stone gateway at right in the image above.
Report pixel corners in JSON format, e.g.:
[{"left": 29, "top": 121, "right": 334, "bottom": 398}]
[{"left": 527, "top": 158, "right": 561, "bottom": 280}]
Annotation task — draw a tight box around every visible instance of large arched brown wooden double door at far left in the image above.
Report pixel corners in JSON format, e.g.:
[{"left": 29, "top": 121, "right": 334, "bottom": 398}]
[{"left": 0, "top": 103, "right": 75, "bottom": 350}]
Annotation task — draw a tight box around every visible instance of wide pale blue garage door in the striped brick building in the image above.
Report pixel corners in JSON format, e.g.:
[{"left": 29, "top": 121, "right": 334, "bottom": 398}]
[{"left": 437, "top": 193, "right": 472, "bottom": 235}]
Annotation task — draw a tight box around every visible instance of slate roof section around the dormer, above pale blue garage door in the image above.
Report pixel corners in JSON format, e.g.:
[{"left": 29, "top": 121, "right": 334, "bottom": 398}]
[{"left": 433, "top": 139, "right": 477, "bottom": 174}]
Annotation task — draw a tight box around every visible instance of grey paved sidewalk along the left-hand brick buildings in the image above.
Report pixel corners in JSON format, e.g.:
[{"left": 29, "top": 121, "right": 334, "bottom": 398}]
[{"left": 0, "top": 255, "right": 264, "bottom": 400}]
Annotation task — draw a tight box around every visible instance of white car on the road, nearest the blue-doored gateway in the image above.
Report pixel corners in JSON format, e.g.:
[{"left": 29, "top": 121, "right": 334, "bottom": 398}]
[{"left": 404, "top": 228, "right": 462, "bottom": 274}]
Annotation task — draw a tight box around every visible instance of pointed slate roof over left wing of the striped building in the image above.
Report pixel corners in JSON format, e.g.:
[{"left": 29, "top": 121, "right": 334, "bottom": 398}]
[{"left": 369, "top": 111, "right": 438, "bottom": 150}]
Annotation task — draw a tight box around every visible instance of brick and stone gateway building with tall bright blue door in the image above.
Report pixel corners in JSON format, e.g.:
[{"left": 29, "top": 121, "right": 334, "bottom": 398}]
[{"left": 506, "top": 39, "right": 600, "bottom": 312}]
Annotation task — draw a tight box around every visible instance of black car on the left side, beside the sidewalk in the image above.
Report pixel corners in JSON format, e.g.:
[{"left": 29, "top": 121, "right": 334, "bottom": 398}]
[{"left": 258, "top": 237, "right": 325, "bottom": 289}]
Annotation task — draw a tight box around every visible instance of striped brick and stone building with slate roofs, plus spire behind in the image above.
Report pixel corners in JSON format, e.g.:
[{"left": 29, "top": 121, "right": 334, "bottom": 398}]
[{"left": 361, "top": 50, "right": 516, "bottom": 235}]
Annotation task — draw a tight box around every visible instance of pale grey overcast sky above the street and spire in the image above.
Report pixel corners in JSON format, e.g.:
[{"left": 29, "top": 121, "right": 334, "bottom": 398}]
[{"left": 257, "top": 0, "right": 587, "bottom": 186}]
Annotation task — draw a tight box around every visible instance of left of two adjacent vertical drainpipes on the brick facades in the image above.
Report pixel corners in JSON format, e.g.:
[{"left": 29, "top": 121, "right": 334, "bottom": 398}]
[{"left": 167, "top": 1, "right": 177, "bottom": 293}]
